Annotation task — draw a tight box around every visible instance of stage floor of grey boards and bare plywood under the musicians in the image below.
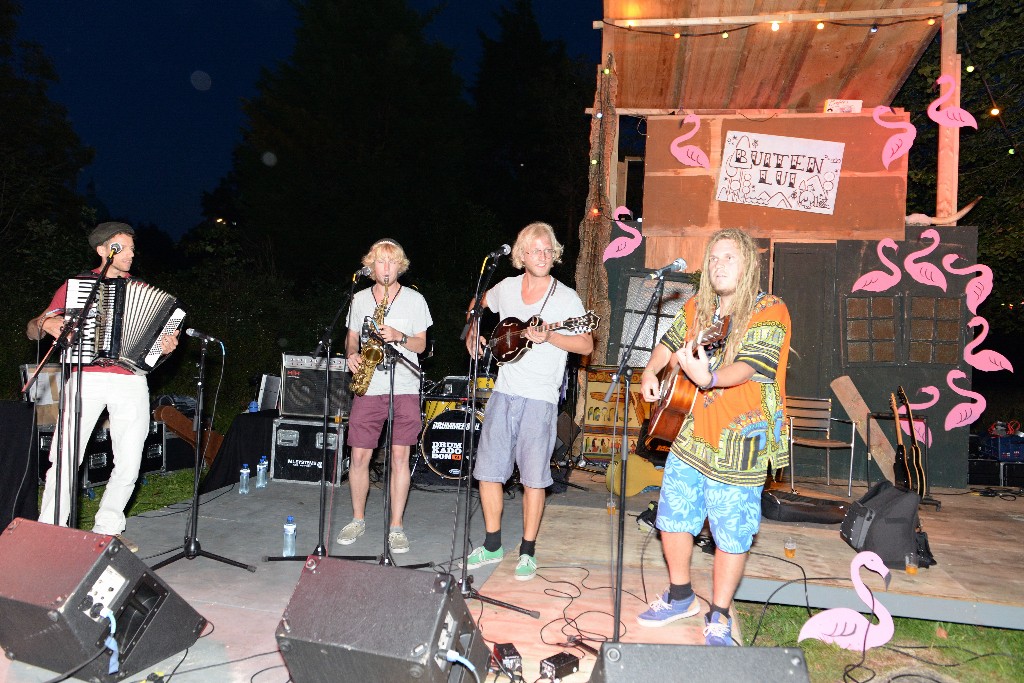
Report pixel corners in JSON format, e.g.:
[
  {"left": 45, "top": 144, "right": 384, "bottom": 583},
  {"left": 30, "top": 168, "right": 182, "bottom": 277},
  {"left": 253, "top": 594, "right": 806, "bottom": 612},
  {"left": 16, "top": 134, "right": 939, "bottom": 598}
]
[{"left": 0, "top": 471, "right": 1024, "bottom": 683}]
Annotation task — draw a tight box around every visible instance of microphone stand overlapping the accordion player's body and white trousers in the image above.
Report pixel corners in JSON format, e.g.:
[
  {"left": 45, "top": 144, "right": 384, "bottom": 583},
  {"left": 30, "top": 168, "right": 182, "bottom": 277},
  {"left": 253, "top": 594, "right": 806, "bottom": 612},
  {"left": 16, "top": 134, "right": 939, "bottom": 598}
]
[{"left": 29, "top": 249, "right": 120, "bottom": 528}]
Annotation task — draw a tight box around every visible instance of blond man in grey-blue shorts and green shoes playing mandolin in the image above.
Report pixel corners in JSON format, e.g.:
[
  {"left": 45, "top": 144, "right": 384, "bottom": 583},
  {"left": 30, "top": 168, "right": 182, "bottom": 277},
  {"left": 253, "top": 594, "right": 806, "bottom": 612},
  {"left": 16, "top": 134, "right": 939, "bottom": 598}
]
[{"left": 466, "top": 223, "right": 594, "bottom": 581}]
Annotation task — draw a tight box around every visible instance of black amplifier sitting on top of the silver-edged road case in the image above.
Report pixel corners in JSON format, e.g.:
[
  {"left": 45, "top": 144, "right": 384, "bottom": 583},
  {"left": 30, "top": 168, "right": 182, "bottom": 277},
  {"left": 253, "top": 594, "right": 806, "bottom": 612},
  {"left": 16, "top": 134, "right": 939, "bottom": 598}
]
[{"left": 281, "top": 353, "right": 352, "bottom": 418}]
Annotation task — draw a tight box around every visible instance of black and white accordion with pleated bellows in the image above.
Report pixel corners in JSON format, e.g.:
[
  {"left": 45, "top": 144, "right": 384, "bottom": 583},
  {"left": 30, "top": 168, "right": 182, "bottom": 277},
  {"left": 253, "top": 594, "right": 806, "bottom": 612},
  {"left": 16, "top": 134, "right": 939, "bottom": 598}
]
[{"left": 61, "top": 278, "right": 185, "bottom": 374}]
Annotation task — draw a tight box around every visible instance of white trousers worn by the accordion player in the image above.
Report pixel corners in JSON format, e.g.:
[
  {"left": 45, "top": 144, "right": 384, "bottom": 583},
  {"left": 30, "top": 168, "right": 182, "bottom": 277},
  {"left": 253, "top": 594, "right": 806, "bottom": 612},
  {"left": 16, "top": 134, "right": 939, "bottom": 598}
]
[{"left": 39, "top": 373, "right": 150, "bottom": 535}]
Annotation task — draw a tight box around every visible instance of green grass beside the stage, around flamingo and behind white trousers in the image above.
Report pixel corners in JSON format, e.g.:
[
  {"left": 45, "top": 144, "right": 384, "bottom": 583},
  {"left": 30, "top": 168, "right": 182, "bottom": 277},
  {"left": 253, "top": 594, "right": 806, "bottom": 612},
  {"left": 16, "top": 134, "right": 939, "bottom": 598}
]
[{"left": 64, "top": 469, "right": 1024, "bottom": 683}]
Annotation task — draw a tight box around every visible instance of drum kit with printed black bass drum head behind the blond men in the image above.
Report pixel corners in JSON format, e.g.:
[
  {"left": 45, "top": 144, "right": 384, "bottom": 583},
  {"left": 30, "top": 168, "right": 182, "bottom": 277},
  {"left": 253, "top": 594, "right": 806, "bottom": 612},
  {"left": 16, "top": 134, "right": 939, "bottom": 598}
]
[{"left": 420, "top": 375, "right": 495, "bottom": 479}]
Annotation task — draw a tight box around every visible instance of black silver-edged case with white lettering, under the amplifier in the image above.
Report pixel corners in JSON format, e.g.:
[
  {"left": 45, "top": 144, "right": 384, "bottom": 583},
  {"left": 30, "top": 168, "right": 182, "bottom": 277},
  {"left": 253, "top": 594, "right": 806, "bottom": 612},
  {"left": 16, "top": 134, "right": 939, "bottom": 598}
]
[{"left": 270, "top": 418, "right": 345, "bottom": 483}]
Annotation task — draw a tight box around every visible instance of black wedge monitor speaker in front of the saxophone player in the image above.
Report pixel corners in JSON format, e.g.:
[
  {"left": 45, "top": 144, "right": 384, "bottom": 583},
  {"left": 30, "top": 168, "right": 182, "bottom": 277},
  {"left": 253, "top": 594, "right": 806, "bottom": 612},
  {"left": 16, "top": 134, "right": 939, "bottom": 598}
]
[{"left": 276, "top": 556, "right": 489, "bottom": 683}]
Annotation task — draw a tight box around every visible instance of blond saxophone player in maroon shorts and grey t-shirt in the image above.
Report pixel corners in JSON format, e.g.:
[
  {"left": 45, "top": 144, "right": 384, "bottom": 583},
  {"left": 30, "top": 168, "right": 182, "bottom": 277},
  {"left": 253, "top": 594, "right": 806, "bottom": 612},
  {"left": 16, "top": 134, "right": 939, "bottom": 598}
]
[{"left": 338, "top": 239, "right": 433, "bottom": 553}]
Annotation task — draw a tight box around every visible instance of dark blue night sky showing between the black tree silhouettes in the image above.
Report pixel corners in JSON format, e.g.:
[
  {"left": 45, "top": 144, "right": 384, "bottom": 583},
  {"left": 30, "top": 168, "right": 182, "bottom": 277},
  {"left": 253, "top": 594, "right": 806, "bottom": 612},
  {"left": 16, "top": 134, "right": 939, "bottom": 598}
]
[{"left": 18, "top": 0, "right": 602, "bottom": 238}]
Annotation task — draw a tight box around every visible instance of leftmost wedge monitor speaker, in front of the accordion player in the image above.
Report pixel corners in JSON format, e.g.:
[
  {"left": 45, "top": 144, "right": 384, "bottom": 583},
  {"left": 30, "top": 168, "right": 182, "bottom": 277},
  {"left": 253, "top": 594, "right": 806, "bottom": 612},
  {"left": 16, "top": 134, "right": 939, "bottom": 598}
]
[{"left": 0, "top": 518, "right": 206, "bottom": 681}]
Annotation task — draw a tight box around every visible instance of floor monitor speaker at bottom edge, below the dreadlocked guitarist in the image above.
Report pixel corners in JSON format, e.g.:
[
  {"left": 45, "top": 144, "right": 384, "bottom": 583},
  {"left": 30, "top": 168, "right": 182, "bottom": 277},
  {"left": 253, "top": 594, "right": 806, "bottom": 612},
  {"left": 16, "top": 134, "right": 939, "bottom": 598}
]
[{"left": 590, "top": 643, "right": 810, "bottom": 683}]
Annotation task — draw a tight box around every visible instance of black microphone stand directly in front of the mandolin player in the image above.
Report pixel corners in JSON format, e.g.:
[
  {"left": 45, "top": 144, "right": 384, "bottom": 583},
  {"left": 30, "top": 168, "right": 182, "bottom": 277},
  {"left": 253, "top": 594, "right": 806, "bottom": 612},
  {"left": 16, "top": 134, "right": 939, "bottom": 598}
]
[{"left": 456, "top": 258, "right": 541, "bottom": 618}]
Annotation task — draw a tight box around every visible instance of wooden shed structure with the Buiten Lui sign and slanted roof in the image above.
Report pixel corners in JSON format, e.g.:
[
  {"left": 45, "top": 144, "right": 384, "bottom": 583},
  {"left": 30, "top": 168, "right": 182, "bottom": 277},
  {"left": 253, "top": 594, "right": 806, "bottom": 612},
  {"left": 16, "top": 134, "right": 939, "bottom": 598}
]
[{"left": 577, "top": 0, "right": 977, "bottom": 486}]
